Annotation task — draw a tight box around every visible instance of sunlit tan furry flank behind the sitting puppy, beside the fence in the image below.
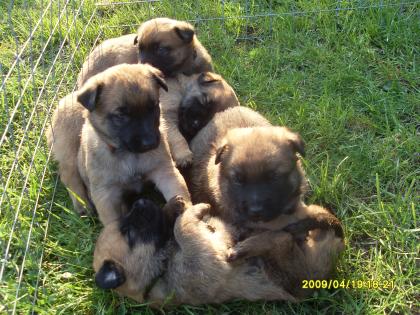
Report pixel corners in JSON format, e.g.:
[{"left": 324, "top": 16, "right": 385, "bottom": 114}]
[{"left": 47, "top": 94, "right": 93, "bottom": 214}]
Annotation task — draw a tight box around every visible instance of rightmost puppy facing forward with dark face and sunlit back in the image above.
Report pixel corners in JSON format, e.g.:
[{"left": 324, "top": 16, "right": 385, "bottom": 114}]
[{"left": 190, "top": 107, "right": 303, "bottom": 220}]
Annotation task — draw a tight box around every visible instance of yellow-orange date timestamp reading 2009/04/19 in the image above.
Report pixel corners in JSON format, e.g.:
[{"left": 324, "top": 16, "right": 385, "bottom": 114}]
[{"left": 302, "top": 279, "right": 395, "bottom": 289}]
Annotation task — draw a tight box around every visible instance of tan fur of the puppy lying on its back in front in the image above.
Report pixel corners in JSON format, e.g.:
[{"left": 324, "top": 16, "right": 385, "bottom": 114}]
[{"left": 94, "top": 199, "right": 296, "bottom": 306}]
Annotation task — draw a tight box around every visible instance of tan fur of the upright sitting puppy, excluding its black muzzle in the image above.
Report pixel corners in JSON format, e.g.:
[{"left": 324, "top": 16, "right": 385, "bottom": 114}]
[{"left": 48, "top": 65, "right": 189, "bottom": 224}]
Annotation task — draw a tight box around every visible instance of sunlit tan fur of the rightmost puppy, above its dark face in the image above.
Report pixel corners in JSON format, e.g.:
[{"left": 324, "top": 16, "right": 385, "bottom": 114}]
[{"left": 189, "top": 107, "right": 303, "bottom": 222}]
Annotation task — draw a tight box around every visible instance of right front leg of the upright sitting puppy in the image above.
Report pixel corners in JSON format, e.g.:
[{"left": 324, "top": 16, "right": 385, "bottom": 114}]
[{"left": 147, "top": 161, "right": 191, "bottom": 207}]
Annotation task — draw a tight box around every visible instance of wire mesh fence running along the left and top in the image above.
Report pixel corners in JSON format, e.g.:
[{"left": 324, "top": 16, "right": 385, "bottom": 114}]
[{"left": 0, "top": 0, "right": 420, "bottom": 314}]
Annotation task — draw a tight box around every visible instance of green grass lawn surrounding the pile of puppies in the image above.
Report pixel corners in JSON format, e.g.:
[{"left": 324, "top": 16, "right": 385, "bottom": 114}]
[{"left": 0, "top": 0, "right": 420, "bottom": 314}]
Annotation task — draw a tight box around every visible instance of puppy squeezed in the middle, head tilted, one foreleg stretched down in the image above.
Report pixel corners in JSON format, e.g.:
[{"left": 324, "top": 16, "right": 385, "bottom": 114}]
[{"left": 160, "top": 72, "right": 239, "bottom": 167}]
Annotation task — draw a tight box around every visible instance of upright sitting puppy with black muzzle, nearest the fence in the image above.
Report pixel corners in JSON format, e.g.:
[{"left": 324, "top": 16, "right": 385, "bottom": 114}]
[{"left": 48, "top": 64, "right": 189, "bottom": 224}]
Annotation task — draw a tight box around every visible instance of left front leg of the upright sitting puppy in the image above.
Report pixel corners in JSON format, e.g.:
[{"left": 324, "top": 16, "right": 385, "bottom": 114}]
[{"left": 91, "top": 186, "right": 126, "bottom": 225}]
